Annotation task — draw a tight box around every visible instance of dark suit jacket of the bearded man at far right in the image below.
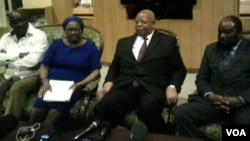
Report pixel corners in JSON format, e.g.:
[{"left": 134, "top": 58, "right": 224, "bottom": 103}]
[{"left": 196, "top": 39, "right": 250, "bottom": 102}]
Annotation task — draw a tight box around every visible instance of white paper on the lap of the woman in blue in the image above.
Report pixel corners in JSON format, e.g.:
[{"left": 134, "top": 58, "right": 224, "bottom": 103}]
[{"left": 43, "top": 80, "right": 74, "bottom": 102}]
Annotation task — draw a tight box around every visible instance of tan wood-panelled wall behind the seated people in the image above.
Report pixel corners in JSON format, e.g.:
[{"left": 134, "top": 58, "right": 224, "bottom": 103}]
[{"left": 0, "top": 0, "right": 250, "bottom": 69}]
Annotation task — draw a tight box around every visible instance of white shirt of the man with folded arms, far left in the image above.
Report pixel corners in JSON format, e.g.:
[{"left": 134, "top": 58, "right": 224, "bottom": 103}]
[{"left": 0, "top": 24, "right": 48, "bottom": 79}]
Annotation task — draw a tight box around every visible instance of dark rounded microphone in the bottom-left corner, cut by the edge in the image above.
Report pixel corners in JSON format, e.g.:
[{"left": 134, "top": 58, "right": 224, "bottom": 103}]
[{"left": 0, "top": 114, "right": 18, "bottom": 138}]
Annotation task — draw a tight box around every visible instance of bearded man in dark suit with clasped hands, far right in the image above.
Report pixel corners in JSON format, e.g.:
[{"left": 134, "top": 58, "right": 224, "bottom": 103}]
[{"left": 175, "top": 16, "right": 250, "bottom": 138}]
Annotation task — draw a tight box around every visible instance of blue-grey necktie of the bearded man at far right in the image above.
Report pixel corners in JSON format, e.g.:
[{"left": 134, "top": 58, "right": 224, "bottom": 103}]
[{"left": 220, "top": 51, "right": 233, "bottom": 72}]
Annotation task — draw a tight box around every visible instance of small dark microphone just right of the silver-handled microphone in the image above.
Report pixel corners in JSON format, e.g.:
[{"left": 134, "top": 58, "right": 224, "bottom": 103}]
[{"left": 97, "top": 122, "right": 111, "bottom": 141}]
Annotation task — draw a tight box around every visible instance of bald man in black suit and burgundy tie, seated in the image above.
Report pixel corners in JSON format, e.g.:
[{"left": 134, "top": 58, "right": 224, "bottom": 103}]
[{"left": 94, "top": 9, "right": 186, "bottom": 133}]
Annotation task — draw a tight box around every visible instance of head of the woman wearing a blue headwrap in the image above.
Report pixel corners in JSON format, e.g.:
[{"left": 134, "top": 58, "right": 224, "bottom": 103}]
[{"left": 62, "top": 16, "right": 84, "bottom": 43}]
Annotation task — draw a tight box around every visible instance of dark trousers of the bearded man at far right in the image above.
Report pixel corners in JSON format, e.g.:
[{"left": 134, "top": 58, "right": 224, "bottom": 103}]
[{"left": 174, "top": 97, "right": 250, "bottom": 138}]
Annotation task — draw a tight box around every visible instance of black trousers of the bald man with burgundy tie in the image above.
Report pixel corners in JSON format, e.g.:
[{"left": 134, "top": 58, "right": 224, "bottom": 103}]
[{"left": 97, "top": 85, "right": 166, "bottom": 133}]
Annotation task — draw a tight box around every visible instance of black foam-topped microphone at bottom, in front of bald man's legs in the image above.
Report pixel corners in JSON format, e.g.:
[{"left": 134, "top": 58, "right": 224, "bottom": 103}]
[{"left": 129, "top": 121, "right": 148, "bottom": 141}]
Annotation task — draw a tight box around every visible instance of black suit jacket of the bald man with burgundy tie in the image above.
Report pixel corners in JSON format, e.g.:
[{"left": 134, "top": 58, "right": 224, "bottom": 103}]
[{"left": 105, "top": 31, "right": 186, "bottom": 102}]
